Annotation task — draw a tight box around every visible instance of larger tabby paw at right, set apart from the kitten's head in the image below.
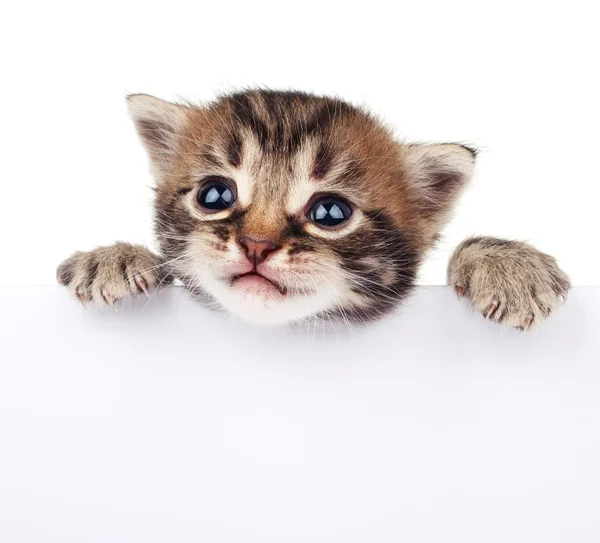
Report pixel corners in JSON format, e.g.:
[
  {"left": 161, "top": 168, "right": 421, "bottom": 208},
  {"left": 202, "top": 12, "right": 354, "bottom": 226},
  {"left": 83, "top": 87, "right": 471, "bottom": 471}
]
[{"left": 448, "top": 237, "right": 571, "bottom": 330}]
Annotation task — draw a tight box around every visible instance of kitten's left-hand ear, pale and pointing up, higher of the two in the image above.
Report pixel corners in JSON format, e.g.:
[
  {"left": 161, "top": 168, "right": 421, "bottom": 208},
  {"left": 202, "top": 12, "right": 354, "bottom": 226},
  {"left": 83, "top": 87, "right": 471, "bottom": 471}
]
[{"left": 127, "top": 94, "right": 190, "bottom": 182}]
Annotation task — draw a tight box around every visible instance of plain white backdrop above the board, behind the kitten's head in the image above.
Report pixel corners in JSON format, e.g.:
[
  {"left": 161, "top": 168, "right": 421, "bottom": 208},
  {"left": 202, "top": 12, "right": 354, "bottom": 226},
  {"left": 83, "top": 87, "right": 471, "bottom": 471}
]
[{"left": 0, "top": 0, "right": 600, "bottom": 285}]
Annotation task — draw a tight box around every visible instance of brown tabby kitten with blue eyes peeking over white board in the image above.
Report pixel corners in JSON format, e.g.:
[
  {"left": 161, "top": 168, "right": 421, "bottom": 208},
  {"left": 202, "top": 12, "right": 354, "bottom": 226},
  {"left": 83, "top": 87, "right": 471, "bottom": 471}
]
[{"left": 57, "top": 90, "right": 570, "bottom": 329}]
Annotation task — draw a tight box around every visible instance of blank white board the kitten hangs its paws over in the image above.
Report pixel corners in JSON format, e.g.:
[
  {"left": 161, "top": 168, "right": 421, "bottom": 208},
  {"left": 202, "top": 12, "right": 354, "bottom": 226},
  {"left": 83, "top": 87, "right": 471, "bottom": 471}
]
[{"left": 0, "top": 287, "right": 600, "bottom": 543}]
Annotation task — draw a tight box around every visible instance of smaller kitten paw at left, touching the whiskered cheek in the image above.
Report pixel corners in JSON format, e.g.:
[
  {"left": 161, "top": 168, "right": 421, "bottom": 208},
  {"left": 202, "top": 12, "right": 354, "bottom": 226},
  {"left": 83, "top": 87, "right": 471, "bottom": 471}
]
[{"left": 56, "top": 242, "right": 165, "bottom": 308}]
